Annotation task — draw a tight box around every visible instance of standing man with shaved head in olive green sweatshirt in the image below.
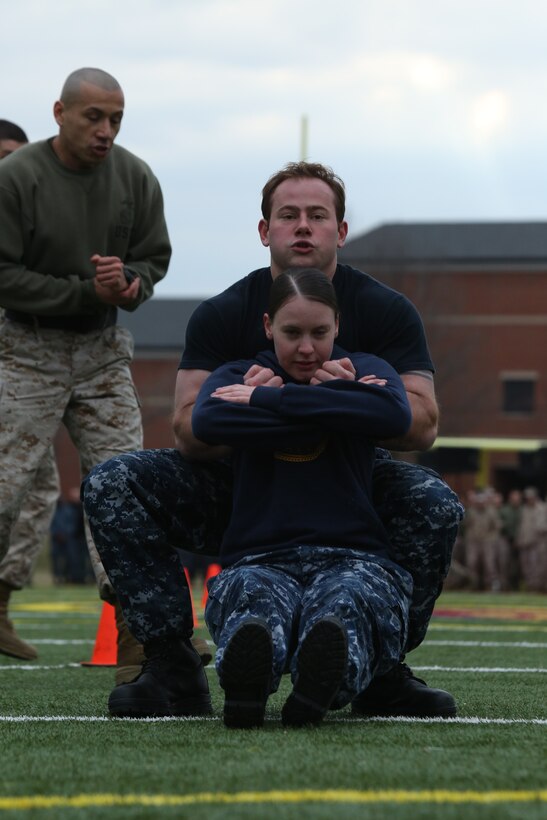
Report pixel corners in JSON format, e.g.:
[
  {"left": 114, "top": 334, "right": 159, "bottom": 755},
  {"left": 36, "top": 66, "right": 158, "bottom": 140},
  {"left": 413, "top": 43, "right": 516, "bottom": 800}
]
[{"left": 0, "top": 68, "right": 171, "bottom": 684}]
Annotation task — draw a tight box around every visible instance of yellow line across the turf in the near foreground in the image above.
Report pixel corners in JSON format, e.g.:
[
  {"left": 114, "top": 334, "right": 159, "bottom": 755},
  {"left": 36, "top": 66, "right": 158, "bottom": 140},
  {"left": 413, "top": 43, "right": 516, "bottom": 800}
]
[{"left": 0, "top": 789, "right": 547, "bottom": 811}]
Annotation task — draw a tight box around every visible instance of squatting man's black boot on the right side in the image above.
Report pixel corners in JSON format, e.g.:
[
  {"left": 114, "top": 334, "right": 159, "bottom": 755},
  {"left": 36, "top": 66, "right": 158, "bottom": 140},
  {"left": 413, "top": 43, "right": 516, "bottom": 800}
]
[{"left": 351, "top": 662, "right": 457, "bottom": 718}]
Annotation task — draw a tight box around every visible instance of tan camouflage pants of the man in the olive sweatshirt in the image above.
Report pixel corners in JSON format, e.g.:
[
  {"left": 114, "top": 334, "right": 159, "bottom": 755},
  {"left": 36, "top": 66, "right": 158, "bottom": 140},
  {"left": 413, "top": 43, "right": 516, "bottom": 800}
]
[{"left": 0, "top": 319, "right": 143, "bottom": 599}]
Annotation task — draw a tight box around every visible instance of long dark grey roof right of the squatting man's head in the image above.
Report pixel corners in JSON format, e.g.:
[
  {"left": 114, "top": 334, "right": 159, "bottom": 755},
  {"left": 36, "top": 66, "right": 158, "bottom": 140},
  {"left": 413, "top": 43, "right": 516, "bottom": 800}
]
[{"left": 338, "top": 222, "right": 547, "bottom": 264}]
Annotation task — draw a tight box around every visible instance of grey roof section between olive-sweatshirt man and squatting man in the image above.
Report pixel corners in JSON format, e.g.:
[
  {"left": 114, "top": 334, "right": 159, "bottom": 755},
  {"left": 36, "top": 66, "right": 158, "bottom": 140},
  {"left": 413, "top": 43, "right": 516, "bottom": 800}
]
[{"left": 118, "top": 299, "right": 203, "bottom": 354}]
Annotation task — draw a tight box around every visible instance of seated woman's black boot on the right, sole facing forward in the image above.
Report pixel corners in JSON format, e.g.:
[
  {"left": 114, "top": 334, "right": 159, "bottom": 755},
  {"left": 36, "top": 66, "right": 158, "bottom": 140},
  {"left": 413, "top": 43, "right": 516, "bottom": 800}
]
[{"left": 281, "top": 618, "right": 348, "bottom": 727}]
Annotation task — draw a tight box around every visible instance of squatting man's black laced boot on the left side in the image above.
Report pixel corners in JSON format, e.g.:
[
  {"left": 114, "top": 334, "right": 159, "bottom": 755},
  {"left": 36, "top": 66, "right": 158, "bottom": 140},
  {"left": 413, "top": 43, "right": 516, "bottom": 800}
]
[{"left": 108, "top": 638, "right": 212, "bottom": 718}]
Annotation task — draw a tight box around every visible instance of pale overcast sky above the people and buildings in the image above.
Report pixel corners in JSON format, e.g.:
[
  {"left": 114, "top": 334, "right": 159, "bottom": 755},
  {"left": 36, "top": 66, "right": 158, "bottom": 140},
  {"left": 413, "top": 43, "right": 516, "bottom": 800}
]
[{"left": 4, "top": 0, "right": 547, "bottom": 297}]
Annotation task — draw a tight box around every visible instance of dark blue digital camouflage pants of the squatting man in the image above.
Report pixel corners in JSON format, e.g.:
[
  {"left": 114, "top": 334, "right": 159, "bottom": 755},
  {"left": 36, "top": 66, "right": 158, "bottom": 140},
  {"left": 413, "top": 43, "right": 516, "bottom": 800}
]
[{"left": 82, "top": 449, "right": 463, "bottom": 651}]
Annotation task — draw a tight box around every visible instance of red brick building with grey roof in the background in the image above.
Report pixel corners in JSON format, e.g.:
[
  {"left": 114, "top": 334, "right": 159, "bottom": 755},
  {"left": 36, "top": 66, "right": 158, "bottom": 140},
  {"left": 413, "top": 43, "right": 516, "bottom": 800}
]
[{"left": 56, "top": 222, "right": 547, "bottom": 493}]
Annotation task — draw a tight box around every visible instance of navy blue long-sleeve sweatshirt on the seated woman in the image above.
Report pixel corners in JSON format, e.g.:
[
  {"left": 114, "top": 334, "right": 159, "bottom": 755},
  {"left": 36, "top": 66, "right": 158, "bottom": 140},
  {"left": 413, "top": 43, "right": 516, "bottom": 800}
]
[{"left": 192, "top": 347, "right": 411, "bottom": 565}]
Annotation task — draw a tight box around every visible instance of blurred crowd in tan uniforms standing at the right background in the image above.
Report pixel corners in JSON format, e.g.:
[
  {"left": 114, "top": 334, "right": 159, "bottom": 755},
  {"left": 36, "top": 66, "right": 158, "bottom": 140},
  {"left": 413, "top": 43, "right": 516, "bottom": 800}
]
[{"left": 446, "top": 487, "right": 547, "bottom": 592}]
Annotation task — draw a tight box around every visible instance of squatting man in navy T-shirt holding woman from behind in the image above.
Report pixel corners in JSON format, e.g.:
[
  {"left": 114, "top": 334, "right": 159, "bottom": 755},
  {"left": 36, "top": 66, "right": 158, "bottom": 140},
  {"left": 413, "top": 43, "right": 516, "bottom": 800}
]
[{"left": 83, "top": 162, "right": 462, "bottom": 717}]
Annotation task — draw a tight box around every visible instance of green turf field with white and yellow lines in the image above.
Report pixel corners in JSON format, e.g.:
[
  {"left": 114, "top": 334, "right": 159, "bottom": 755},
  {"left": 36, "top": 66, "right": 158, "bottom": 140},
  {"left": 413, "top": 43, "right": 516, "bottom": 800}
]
[{"left": 0, "top": 587, "right": 547, "bottom": 820}]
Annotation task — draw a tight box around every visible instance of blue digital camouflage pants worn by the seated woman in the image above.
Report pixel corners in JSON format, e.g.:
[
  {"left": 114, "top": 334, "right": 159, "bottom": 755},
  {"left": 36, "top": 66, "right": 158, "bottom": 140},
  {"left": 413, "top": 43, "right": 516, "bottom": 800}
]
[{"left": 205, "top": 547, "right": 412, "bottom": 709}]
